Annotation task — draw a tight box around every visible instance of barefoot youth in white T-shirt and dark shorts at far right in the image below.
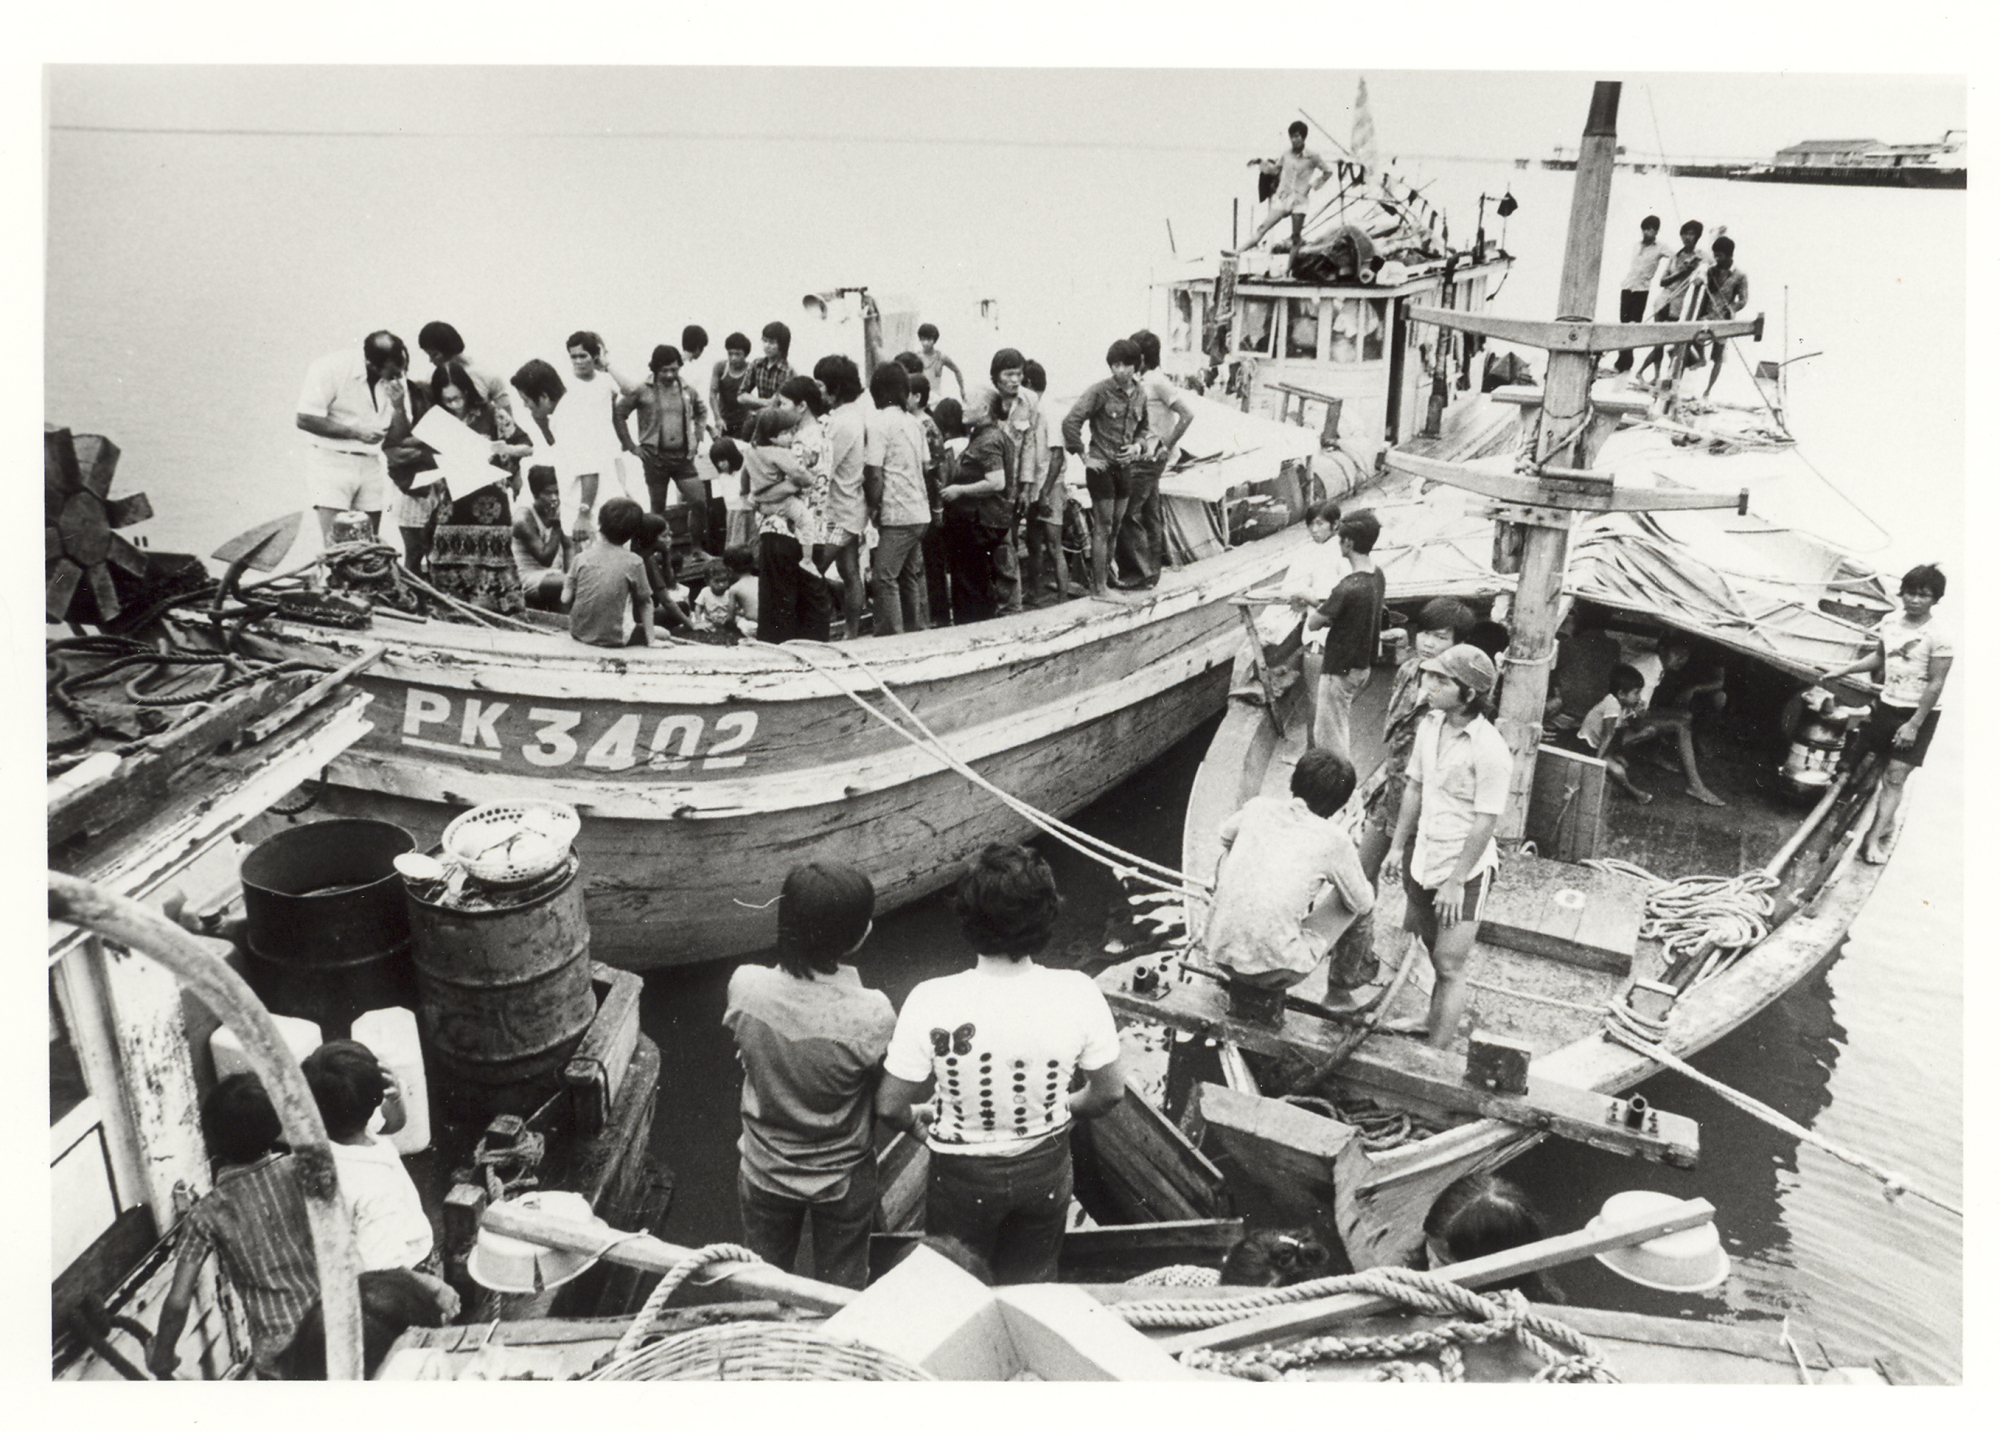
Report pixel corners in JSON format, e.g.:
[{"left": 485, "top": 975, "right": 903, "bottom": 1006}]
[{"left": 1826, "top": 564, "right": 1952, "bottom": 866}]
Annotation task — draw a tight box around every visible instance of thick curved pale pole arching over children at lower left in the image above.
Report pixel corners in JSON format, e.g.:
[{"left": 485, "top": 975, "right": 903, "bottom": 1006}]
[{"left": 48, "top": 870, "right": 362, "bottom": 1382}]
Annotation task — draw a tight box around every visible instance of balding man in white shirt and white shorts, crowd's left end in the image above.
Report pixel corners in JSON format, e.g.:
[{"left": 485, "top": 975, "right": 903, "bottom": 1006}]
[{"left": 298, "top": 328, "right": 410, "bottom": 538}]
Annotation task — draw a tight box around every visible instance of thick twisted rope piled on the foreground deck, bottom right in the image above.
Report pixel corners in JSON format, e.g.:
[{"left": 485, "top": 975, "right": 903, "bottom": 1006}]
[{"left": 1112, "top": 1268, "right": 1618, "bottom": 1382}]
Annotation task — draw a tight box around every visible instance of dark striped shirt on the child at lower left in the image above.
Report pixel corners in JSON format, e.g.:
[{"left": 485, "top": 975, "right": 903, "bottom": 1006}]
[{"left": 180, "top": 1154, "right": 320, "bottom": 1376}]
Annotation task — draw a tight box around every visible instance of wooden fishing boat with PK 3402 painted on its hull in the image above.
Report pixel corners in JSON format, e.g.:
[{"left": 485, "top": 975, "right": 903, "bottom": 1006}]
[{"left": 182, "top": 226, "right": 1510, "bottom": 970}]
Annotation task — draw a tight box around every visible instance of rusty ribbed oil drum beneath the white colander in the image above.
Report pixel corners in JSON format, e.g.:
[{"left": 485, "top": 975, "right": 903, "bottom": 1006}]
[{"left": 406, "top": 858, "right": 598, "bottom": 1120}]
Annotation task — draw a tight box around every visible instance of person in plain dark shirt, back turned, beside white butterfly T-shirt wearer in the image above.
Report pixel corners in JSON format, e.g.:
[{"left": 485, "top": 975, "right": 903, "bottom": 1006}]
[{"left": 722, "top": 860, "right": 896, "bottom": 1288}]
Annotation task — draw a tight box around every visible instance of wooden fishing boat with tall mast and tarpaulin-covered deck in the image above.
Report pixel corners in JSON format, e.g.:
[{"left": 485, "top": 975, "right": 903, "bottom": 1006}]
[{"left": 1100, "top": 86, "right": 1890, "bottom": 1268}]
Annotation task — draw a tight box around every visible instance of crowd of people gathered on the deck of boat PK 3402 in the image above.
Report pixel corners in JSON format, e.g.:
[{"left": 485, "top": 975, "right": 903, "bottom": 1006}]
[{"left": 298, "top": 322, "right": 1194, "bottom": 646}]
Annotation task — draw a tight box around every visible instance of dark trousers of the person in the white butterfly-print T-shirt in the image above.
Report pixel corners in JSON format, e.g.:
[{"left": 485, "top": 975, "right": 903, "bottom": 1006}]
[{"left": 924, "top": 1132, "right": 1074, "bottom": 1284}]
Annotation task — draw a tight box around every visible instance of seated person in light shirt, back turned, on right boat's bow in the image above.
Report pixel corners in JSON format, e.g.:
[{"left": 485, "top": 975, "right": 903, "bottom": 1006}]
[{"left": 1204, "top": 746, "right": 1374, "bottom": 988}]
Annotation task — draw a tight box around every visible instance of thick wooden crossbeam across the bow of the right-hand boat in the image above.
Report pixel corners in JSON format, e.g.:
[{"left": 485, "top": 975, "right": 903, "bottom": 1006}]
[{"left": 1098, "top": 966, "right": 1700, "bottom": 1168}]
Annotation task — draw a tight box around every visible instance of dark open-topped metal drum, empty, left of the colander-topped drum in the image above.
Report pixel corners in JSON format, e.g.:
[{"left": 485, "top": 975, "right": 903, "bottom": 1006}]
[{"left": 242, "top": 820, "right": 416, "bottom": 1038}]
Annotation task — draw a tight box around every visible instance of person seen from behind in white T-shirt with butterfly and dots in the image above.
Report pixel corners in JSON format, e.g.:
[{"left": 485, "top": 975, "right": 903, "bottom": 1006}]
[{"left": 876, "top": 844, "right": 1124, "bottom": 1284}]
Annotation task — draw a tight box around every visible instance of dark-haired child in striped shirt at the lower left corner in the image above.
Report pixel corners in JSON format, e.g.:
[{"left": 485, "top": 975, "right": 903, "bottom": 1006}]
[{"left": 146, "top": 1074, "right": 320, "bottom": 1378}]
